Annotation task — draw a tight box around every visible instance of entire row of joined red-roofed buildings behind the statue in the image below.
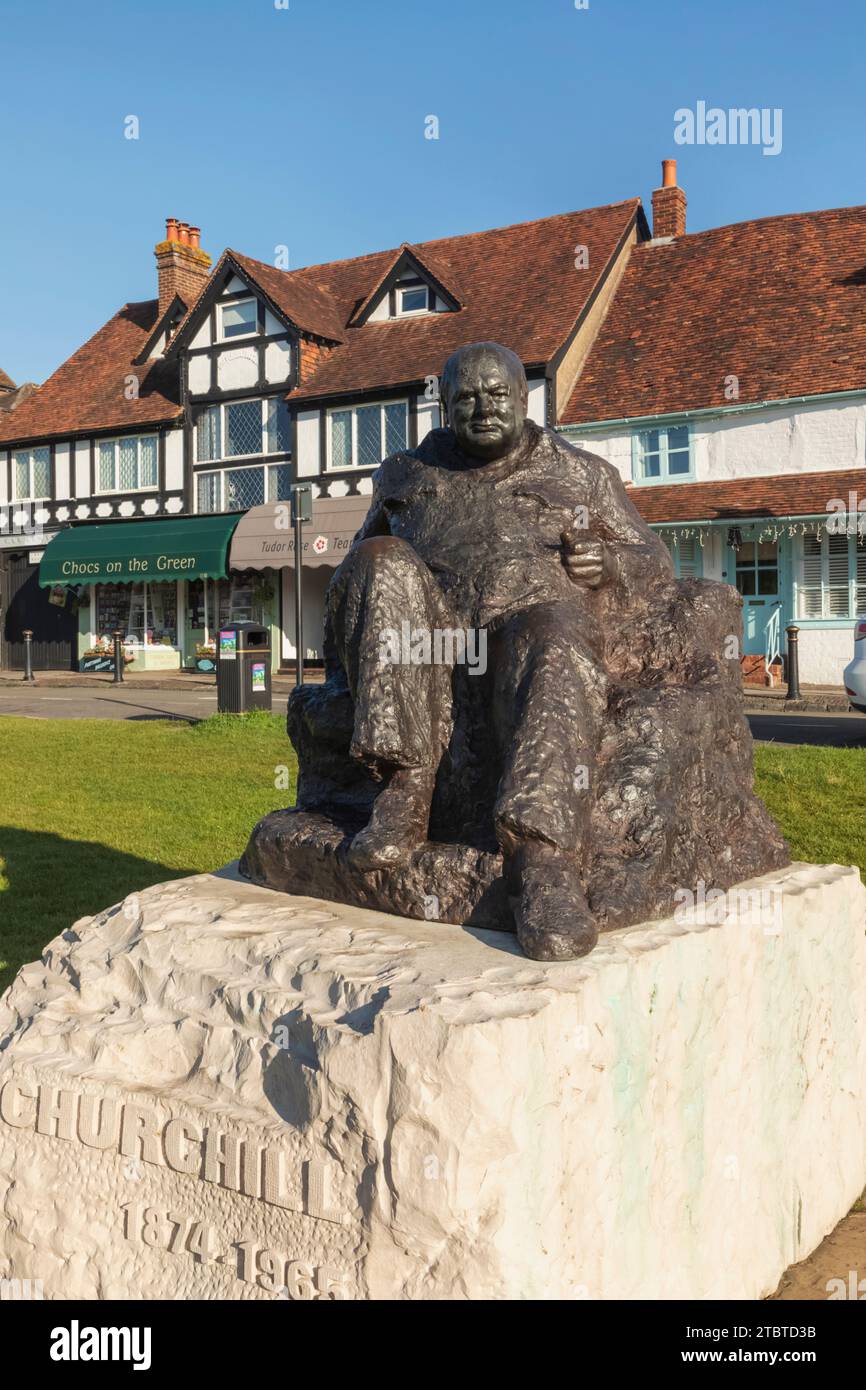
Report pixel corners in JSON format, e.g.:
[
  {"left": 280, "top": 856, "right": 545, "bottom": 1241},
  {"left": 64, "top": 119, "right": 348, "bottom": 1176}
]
[{"left": 6, "top": 160, "right": 866, "bottom": 684}]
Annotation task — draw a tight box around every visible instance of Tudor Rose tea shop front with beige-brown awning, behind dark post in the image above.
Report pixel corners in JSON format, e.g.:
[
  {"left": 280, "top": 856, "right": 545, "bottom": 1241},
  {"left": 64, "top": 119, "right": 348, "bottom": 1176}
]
[{"left": 229, "top": 496, "right": 370, "bottom": 663}]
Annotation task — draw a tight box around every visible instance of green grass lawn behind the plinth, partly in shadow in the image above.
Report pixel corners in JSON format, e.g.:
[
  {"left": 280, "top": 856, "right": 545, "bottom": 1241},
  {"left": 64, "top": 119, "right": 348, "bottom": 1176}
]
[{"left": 0, "top": 714, "right": 866, "bottom": 990}]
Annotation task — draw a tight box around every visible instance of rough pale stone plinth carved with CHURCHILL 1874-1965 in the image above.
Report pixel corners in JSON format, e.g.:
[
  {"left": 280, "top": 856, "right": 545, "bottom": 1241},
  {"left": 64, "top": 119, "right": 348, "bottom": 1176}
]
[{"left": 0, "top": 865, "right": 866, "bottom": 1300}]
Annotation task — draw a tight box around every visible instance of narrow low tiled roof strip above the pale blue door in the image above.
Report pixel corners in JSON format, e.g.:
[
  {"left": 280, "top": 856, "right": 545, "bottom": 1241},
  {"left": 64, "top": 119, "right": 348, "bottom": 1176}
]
[{"left": 628, "top": 467, "right": 866, "bottom": 523}]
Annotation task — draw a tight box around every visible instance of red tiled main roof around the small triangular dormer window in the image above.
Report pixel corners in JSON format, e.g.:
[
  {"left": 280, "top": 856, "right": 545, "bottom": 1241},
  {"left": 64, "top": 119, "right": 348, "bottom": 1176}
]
[{"left": 275, "top": 199, "right": 639, "bottom": 400}]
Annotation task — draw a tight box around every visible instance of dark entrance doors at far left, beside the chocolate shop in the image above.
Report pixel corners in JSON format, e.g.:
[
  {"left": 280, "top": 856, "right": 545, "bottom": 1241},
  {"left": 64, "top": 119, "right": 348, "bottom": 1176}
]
[{"left": 0, "top": 552, "right": 78, "bottom": 671}]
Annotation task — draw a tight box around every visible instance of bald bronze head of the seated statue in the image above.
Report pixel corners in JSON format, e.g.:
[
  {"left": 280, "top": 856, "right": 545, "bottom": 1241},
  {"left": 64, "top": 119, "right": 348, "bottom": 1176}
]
[{"left": 439, "top": 343, "right": 528, "bottom": 463}]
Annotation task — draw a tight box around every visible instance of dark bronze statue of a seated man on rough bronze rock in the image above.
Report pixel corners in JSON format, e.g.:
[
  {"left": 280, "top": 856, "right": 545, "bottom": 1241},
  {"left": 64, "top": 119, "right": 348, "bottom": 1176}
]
[{"left": 242, "top": 343, "right": 788, "bottom": 960}]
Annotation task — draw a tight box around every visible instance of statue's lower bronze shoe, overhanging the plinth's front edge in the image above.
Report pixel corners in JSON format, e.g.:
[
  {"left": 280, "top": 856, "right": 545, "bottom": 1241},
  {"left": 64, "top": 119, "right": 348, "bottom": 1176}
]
[{"left": 513, "top": 847, "right": 598, "bottom": 960}]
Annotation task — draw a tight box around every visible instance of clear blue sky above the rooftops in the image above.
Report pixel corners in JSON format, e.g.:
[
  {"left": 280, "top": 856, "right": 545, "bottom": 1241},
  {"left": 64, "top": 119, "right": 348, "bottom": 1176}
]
[{"left": 0, "top": 0, "right": 866, "bottom": 381}]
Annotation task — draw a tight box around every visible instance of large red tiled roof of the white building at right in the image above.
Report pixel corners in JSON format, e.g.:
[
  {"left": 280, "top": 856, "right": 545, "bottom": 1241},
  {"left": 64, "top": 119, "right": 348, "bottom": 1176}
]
[{"left": 562, "top": 207, "right": 866, "bottom": 424}]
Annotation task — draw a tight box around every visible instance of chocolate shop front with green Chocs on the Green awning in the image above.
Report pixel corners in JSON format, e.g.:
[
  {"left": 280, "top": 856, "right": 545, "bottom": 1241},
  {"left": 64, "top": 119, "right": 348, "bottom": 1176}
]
[{"left": 39, "top": 516, "right": 279, "bottom": 671}]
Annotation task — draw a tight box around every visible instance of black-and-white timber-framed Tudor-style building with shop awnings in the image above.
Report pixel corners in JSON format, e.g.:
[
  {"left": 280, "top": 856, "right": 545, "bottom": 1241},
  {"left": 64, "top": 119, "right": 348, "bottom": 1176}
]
[{"left": 0, "top": 199, "right": 648, "bottom": 670}]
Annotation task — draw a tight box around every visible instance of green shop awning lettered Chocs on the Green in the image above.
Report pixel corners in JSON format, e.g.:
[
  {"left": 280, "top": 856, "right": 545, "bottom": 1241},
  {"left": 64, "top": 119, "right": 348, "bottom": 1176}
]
[{"left": 39, "top": 513, "right": 240, "bottom": 588}]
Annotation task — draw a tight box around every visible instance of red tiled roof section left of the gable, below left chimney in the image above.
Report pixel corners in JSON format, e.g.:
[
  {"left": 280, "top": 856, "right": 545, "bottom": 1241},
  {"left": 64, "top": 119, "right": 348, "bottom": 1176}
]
[{"left": 0, "top": 299, "right": 181, "bottom": 442}]
